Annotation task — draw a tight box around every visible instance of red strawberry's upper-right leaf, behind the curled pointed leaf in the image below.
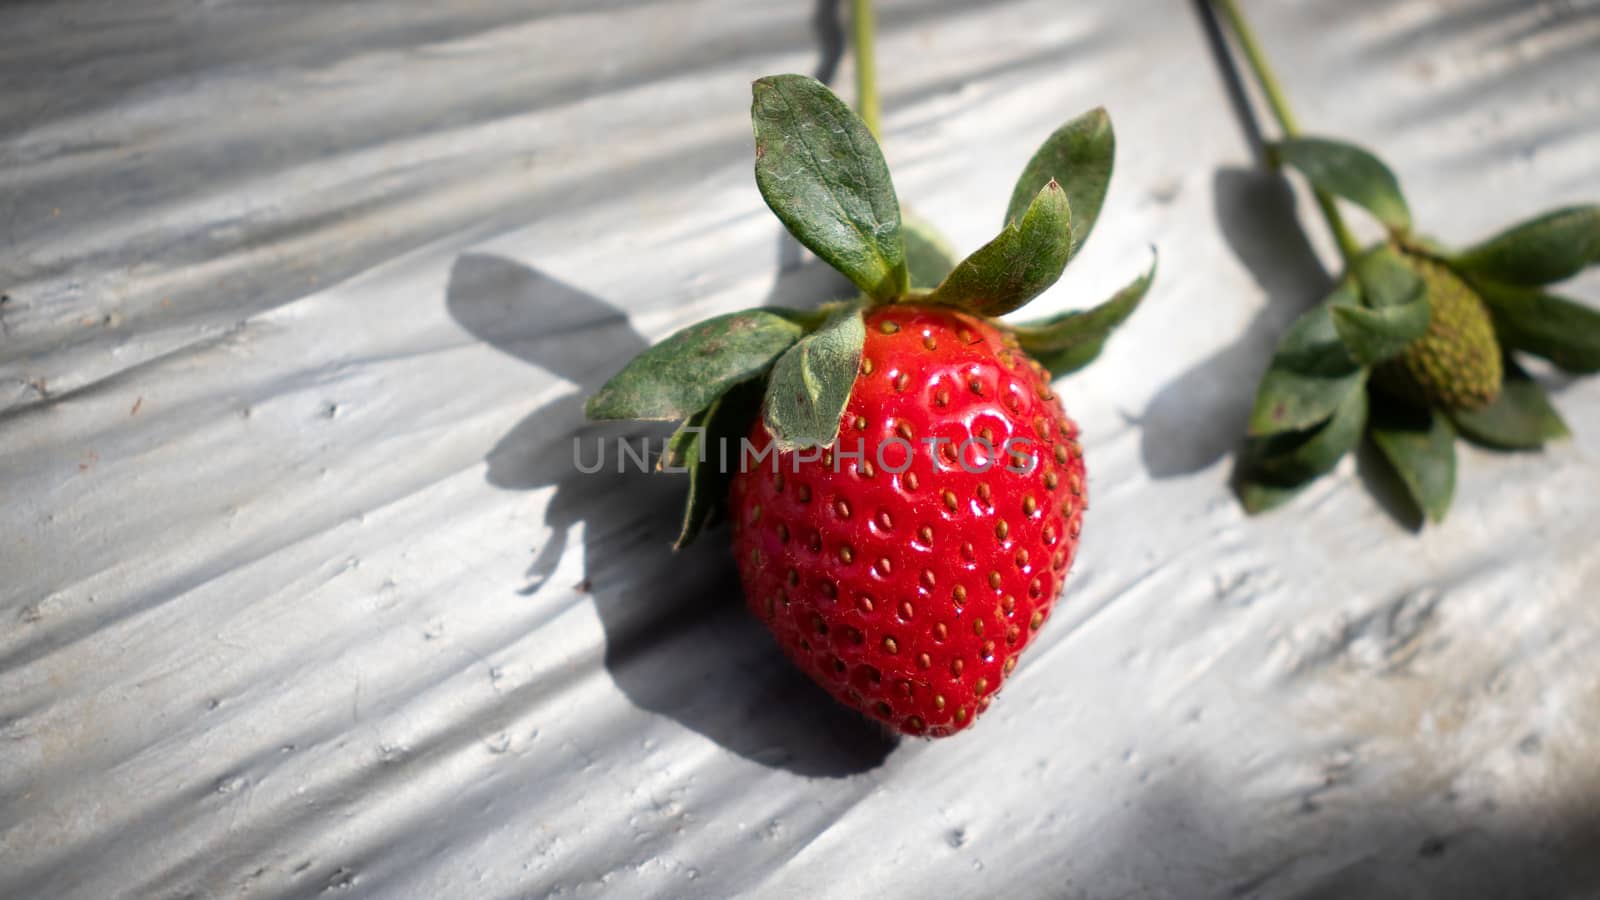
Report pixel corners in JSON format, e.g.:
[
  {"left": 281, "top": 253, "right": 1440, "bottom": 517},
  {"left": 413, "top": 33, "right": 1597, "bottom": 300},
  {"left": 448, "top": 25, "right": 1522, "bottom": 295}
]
[{"left": 1005, "top": 107, "right": 1117, "bottom": 258}]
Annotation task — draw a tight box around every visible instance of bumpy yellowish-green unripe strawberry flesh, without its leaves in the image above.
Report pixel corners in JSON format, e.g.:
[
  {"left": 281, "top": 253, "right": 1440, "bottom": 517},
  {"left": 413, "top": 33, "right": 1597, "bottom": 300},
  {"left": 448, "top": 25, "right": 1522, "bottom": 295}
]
[{"left": 1384, "top": 255, "right": 1502, "bottom": 410}]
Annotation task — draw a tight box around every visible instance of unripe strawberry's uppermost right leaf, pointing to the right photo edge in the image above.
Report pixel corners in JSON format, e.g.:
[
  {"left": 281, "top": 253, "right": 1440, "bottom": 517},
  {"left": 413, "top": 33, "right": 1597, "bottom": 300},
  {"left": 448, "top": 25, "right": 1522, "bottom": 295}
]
[{"left": 1451, "top": 205, "right": 1600, "bottom": 285}]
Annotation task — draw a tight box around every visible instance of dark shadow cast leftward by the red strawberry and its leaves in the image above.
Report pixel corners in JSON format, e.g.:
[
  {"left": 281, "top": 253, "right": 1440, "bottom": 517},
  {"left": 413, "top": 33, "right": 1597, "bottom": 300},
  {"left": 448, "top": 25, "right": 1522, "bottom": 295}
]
[{"left": 446, "top": 250, "right": 896, "bottom": 777}]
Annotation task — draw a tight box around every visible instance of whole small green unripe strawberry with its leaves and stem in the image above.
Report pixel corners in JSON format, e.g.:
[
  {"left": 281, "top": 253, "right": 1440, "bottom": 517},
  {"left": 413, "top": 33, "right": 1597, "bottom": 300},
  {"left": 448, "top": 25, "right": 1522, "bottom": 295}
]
[{"left": 1216, "top": 14, "right": 1600, "bottom": 525}]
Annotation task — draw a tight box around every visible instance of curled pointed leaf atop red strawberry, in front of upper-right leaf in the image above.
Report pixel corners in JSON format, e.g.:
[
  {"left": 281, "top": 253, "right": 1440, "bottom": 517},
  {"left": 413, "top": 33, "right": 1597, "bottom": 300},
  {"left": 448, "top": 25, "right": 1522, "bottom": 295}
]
[{"left": 926, "top": 181, "right": 1072, "bottom": 315}]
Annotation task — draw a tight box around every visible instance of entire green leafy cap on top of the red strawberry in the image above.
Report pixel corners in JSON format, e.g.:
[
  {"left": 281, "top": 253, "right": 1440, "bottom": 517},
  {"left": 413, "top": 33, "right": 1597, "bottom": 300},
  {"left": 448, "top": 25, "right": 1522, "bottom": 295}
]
[{"left": 586, "top": 75, "right": 1155, "bottom": 546}]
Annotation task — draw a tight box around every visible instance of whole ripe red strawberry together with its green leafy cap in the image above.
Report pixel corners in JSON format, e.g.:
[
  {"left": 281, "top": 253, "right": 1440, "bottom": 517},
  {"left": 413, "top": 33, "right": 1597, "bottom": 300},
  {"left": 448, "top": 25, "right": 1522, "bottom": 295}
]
[{"left": 586, "top": 75, "right": 1155, "bottom": 737}]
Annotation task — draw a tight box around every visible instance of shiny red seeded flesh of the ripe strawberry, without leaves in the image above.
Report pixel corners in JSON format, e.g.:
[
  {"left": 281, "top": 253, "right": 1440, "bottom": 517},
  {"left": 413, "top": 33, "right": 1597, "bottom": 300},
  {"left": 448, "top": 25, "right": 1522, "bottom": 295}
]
[{"left": 730, "top": 306, "right": 1085, "bottom": 737}]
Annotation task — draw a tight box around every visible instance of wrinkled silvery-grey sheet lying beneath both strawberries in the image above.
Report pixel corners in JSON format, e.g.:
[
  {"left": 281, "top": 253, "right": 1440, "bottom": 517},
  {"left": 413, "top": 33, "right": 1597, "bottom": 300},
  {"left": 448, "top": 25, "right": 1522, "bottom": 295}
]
[{"left": 0, "top": 0, "right": 1600, "bottom": 898}]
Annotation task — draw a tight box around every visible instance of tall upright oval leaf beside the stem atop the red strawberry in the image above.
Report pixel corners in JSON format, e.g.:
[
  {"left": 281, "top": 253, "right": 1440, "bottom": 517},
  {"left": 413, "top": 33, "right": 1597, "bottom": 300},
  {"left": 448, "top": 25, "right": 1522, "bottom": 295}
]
[{"left": 750, "top": 75, "right": 907, "bottom": 299}]
